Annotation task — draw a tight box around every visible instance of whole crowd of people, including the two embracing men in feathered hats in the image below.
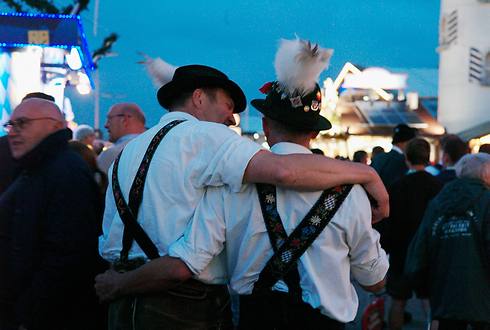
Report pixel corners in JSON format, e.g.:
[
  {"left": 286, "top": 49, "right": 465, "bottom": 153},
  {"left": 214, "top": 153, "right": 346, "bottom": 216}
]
[{"left": 0, "top": 39, "right": 490, "bottom": 330}]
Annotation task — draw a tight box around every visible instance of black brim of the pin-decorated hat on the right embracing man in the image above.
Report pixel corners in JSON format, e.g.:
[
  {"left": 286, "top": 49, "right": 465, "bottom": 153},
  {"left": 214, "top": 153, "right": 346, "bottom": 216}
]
[{"left": 251, "top": 99, "right": 332, "bottom": 131}]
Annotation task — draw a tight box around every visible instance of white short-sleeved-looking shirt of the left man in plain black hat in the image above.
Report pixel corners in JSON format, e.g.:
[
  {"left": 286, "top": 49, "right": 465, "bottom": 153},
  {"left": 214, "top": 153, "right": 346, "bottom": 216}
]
[{"left": 99, "top": 112, "right": 260, "bottom": 283}]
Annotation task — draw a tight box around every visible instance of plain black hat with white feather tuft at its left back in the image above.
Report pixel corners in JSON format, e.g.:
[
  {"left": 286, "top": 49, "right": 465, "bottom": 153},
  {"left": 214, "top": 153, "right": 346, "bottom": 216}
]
[{"left": 142, "top": 54, "right": 247, "bottom": 113}]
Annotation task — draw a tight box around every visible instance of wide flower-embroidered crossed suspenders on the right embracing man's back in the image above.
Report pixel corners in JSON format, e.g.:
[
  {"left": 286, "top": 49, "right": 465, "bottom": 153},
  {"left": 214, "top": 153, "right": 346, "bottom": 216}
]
[{"left": 254, "top": 184, "right": 352, "bottom": 293}]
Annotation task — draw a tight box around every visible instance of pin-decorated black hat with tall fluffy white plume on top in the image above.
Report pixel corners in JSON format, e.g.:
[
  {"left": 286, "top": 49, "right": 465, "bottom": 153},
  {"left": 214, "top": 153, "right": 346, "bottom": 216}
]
[{"left": 251, "top": 38, "right": 333, "bottom": 131}]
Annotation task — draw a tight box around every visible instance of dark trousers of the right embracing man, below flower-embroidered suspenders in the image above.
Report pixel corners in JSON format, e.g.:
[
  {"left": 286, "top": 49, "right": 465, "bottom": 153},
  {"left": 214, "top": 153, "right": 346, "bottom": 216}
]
[{"left": 238, "top": 291, "right": 345, "bottom": 330}]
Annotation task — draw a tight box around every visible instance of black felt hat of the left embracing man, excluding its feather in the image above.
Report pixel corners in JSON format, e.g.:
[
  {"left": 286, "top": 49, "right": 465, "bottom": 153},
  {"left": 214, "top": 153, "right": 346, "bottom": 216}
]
[{"left": 157, "top": 64, "right": 247, "bottom": 113}]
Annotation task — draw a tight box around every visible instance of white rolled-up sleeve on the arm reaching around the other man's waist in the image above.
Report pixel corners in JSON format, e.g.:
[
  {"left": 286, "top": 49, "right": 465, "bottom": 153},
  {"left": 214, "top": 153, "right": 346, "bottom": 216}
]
[{"left": 169, "top": 187, "right": 226, "bottom": 275}]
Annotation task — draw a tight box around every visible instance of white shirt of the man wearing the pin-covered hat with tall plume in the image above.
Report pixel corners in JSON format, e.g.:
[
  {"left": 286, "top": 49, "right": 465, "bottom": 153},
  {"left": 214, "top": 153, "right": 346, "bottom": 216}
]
[{"left": 169, "top": 143, "right": 388, "bottom": 322}]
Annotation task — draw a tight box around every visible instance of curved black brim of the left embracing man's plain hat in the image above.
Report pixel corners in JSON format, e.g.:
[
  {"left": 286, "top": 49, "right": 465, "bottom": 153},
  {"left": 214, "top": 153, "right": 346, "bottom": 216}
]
[{"left": 157, "top": 77, "right": 247, "bottom": 113}]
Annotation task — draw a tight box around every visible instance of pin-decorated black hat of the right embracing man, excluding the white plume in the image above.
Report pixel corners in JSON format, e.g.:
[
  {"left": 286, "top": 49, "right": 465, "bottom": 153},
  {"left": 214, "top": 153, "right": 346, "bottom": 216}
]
[{"left": 251, "top": 81, "right": 332, "bottom": 131}]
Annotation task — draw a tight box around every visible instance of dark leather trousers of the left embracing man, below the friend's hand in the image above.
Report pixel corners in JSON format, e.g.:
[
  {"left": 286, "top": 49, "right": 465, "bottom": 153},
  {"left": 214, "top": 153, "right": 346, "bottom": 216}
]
[{"left": 109, "top": 280, "right": 233, "bottom": 330}]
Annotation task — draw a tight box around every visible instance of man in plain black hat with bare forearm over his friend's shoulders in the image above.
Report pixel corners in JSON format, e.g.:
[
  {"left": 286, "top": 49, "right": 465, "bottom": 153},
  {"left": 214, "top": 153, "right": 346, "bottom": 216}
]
[{"left": 96, "top": 47, "right": 387, "bottom": 329}]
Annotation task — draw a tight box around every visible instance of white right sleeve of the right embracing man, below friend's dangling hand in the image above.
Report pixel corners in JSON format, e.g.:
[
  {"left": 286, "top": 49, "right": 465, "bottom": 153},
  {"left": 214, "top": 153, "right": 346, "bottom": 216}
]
[{"left": 347, "top": 185, "right": 389, "bottom": 286}]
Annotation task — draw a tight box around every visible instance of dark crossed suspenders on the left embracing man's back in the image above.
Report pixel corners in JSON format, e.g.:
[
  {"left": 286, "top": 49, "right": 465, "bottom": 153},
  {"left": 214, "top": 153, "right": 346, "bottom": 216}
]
[{"left": 112, "top": 120, "right": 185, "bottom": 261}]
